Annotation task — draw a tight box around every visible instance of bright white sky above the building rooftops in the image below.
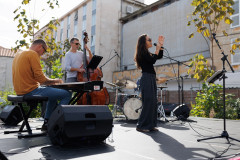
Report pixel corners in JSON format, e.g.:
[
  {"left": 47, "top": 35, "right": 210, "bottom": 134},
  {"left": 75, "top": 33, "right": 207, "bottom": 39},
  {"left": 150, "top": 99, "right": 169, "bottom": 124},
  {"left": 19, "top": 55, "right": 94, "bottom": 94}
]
[{"left": 0, "top": 0, "right": 157, "bottom": 48}]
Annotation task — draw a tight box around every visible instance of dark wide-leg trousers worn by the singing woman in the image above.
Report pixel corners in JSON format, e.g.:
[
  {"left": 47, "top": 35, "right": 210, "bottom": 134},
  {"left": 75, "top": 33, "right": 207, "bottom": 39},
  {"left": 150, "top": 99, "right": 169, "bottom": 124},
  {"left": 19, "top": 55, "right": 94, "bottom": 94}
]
[{"left": 137, "top": 73, "right": 157, "bottom": 130}]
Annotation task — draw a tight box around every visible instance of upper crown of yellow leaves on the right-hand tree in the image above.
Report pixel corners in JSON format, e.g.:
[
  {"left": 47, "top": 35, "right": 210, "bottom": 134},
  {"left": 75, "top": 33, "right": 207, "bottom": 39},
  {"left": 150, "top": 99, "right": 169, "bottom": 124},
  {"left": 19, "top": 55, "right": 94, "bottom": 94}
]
[{"left": 187, "top": 0, "right": 234, "bottom": 40}]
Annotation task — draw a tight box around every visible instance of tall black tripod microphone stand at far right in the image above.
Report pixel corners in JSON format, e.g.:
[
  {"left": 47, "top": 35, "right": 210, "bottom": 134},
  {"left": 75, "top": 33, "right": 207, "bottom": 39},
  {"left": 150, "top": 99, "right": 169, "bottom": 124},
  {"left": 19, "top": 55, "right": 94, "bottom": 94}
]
[{"left": 197, "top": 33, "right": 240, "bottom": 143}]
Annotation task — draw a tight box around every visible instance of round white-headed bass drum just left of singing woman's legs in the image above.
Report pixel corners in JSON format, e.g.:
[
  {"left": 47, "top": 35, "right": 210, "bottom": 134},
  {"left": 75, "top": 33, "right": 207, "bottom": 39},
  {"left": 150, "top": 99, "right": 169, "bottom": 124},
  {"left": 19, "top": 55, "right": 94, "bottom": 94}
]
[{"left": 123, "top": 98, "right": 142, "bottom": 120}]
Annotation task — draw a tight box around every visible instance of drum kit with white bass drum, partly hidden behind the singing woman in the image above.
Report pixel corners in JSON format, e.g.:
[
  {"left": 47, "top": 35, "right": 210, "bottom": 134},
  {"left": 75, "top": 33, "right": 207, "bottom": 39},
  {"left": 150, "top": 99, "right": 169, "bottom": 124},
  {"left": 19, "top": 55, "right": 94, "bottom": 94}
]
[{"left": 105, "top": 78, "right": 168, "bottom": 122}]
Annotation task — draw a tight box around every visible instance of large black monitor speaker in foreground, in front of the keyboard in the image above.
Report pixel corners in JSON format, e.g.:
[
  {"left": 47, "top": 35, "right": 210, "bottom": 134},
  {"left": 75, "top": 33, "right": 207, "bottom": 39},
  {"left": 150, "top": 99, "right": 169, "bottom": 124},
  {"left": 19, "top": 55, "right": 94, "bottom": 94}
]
[{"left": 48, "top": 105, "right": 113, "bottom": 146}]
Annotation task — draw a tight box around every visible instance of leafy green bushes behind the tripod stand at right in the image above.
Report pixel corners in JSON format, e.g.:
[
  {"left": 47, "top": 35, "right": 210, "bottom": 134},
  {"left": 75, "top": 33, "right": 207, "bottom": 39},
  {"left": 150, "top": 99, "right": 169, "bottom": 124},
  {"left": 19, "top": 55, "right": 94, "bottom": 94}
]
[{"left": 191, "top": 83, "right": 240, "bottom": 119}]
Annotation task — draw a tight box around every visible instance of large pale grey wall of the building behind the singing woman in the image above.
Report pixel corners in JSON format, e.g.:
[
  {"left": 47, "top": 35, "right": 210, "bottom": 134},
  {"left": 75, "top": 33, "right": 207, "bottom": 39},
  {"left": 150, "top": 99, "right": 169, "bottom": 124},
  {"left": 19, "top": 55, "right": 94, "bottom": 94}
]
[{"left": 122, "top": 0, "right": 209, "bottom": 69}]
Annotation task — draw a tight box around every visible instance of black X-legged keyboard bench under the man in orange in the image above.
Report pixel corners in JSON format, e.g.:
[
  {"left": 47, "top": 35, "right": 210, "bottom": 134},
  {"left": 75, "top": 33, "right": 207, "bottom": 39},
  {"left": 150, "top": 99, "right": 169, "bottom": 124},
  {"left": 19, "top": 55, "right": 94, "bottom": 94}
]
[{"left": 4, "top": 95, "right": 48, "bottom": 138}]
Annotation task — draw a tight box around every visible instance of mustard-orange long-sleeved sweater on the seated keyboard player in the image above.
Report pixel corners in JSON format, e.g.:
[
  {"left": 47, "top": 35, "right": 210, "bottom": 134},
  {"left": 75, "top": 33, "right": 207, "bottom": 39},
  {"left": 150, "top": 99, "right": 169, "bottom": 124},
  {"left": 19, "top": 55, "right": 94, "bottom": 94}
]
[{"left": 12, "top": 50, "right": 47, "bottom": 95}]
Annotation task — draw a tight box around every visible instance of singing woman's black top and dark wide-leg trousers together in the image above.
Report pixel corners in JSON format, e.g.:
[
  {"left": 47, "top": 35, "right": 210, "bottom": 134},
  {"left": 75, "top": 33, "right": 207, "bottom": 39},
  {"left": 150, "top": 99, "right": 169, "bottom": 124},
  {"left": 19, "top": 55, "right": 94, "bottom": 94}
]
[{"left": 137, "top": 50, "right": 163, "bottom": 130}]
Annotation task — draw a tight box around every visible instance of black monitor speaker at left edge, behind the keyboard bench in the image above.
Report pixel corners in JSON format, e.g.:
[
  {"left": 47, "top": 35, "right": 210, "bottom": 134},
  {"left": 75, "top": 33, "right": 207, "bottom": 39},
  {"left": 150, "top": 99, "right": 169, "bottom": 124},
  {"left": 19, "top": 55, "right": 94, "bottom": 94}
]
[{"left": 0, "top": 105, "right": 23, "bottom": 126}]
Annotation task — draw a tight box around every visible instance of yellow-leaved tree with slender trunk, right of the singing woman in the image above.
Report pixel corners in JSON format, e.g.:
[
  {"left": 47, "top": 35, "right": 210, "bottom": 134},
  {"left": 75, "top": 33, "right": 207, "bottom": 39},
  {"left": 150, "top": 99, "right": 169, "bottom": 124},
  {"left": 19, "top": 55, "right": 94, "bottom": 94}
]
[{"left": 188, "top": 0, "right": 234, "bottom": 80}]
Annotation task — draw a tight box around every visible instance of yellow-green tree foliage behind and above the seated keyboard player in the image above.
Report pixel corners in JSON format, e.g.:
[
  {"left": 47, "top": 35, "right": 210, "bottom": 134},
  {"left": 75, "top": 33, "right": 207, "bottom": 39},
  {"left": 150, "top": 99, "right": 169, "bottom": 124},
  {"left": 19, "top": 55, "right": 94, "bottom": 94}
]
[{"left": 14, "top": 0, "right": 70, "bottom": 78}]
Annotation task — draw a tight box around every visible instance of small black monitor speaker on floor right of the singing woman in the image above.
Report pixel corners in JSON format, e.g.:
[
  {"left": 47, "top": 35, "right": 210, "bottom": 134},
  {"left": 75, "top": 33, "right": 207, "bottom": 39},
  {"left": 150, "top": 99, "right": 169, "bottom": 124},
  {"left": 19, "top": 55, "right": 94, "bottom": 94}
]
[{"left": 173, "top": 104, "right": 190, "bottom": 120}]
